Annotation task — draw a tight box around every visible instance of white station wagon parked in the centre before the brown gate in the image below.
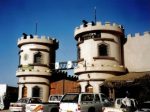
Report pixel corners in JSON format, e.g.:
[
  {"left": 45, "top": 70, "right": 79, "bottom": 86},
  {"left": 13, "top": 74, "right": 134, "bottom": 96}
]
[{"left": 59, "top": 93, "right": 112, "bottom": 112}]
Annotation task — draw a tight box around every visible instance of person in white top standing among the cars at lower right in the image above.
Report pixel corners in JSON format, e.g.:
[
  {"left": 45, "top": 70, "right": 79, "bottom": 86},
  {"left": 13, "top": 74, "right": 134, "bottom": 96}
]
[{"left": 122, "top": 91, "right": 133, "bottom": 112}]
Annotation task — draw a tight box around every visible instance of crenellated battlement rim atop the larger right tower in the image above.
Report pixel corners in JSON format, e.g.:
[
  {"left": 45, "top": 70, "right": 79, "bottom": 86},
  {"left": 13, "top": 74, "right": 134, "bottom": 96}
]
[{"left": 74, "top": 22, "right": 124, "bottom": 37}]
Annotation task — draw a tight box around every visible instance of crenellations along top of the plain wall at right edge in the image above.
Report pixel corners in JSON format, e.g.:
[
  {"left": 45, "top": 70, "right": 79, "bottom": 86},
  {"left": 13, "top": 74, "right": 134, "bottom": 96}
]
[{"left": 127, "top": 31, "right": 150, "bottom": 39}]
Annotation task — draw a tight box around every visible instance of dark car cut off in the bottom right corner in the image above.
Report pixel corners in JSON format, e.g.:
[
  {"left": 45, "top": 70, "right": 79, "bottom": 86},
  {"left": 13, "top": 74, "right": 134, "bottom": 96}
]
[{"left": 136, "top": 101, "right": 150, "bottom": 112}]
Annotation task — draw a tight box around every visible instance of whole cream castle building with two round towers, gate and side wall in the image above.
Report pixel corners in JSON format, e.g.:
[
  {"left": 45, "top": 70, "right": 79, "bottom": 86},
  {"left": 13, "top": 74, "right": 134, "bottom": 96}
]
[{"left": 16, "top": 21, "right": 150, "bottom": 101}]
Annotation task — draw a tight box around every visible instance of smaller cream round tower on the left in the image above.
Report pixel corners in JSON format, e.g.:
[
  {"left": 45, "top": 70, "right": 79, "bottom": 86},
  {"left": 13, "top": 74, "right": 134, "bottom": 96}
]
[{"left": 16, "top": 34, "right": 59, "bottom": 101}]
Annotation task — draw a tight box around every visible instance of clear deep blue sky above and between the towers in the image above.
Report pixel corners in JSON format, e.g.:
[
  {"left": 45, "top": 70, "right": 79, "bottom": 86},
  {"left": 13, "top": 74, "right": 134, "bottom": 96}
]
[{"left": 0, "top": 0, "right": 150, "bottom": 87}]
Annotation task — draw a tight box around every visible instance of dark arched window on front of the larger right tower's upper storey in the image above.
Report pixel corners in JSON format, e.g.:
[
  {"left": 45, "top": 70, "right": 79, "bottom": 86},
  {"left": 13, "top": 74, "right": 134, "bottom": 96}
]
[{"left": 98, "top": 43, "right": 109, "bottom": 56}]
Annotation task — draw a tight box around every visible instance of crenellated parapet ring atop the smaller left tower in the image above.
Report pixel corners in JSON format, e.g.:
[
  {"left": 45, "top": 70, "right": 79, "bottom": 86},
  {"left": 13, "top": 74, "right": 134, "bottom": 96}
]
[{"left": 17, "top": 35, "right": 59, "bottom": 49}]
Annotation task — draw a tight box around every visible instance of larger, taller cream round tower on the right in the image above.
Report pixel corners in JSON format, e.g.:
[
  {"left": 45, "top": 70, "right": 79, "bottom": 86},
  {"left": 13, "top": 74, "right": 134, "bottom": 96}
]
[{"left": 74, "top": 21, "right": 126, "bottom": 92}]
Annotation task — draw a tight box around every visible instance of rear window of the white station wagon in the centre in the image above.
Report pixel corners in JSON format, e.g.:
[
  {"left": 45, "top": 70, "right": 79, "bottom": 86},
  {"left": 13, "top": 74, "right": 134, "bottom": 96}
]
[{"left": 61, "top": 94, "right": 79, "bottom": 103}]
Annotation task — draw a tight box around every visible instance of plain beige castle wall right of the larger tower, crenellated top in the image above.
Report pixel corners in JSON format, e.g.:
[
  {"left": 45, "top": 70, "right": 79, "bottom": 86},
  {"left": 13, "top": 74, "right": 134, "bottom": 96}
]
[{"left": 124, "top": 32, "right": 150, "bottom": 72}]
